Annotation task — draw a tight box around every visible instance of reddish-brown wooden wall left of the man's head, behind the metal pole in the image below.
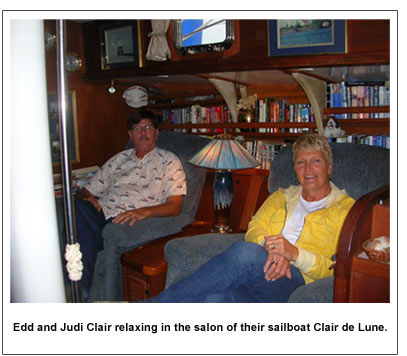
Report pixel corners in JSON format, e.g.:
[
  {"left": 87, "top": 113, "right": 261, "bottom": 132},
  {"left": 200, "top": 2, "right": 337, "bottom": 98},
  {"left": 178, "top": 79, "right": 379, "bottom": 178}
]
[{"left": 44, "top": 20, "right": 132, "bottom": 171}]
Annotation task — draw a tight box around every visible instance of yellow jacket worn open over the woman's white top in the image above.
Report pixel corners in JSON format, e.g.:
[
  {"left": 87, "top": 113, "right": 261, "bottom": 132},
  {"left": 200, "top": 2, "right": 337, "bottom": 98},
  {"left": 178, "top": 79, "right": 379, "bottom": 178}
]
[{"left": 245, "top": 182, "right": 355, "bottom": 283}]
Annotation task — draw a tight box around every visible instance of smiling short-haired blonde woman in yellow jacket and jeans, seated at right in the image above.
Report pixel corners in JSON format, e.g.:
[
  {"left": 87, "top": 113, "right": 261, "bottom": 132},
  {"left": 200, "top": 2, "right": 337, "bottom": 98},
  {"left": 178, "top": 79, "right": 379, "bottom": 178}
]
[{"left": 151, "top": 134, "right": 354, "bottom": 302}]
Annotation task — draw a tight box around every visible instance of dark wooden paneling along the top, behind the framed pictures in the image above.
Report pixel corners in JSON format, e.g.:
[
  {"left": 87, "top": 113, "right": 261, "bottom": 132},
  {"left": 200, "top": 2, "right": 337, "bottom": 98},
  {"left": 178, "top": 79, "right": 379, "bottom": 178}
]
[{"left": 83, "top": 20, "right": 390, "bottom": 78}]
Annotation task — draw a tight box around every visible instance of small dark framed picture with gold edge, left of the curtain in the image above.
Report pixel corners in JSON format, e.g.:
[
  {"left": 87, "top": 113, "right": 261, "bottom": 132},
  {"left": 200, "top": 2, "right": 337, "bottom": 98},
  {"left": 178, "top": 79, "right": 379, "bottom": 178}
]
[{"left": 100, "top": 20, "right": 143, "bottom": 70}]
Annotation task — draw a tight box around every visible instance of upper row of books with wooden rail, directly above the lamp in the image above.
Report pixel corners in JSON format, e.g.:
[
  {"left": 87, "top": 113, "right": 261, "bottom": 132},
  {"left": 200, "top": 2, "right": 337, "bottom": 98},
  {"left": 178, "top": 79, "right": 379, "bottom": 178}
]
[{"left": 158, "top": 92, "right": 317, "bottom": 142}]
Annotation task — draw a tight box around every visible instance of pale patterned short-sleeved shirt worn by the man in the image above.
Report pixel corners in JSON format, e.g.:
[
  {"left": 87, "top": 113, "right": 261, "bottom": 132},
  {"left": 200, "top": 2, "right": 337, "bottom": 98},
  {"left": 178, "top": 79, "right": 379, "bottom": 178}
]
[{"left": 85, "top": 147, "right": 186, "bottom": 219}]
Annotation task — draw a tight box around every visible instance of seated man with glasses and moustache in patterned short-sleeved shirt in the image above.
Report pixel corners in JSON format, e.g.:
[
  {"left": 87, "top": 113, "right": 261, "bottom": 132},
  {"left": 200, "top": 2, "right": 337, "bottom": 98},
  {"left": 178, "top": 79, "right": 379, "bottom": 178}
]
[{"left": 75, "top": 110, "right": 186, "bottom": 299}]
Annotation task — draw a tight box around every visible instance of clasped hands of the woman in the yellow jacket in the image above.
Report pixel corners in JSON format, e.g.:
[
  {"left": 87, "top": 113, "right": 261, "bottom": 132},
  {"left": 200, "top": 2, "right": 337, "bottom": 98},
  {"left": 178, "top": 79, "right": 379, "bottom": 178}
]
[{"left": 264, "top": 235, "right": 298, "bottom": 281}]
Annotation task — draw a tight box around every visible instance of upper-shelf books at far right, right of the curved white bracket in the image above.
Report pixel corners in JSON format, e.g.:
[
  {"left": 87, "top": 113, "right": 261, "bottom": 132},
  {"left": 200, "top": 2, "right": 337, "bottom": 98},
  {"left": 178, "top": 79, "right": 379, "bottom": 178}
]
[{"left": 327, "top": 82, "right": 390, "bottom": 119}]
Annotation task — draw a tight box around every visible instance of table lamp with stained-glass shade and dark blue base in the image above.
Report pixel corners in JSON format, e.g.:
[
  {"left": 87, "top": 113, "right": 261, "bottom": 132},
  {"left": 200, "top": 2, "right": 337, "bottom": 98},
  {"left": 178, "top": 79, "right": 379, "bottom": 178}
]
[{"left": 189, "top": 134, "right": 260, "bottom": 233}]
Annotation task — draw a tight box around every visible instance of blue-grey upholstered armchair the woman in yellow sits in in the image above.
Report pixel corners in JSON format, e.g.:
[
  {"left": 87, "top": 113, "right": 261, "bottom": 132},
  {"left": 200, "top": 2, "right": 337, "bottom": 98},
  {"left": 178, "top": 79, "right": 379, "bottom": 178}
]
[{"left": 165, "top": 143, "right": 390, "bottom": 303}]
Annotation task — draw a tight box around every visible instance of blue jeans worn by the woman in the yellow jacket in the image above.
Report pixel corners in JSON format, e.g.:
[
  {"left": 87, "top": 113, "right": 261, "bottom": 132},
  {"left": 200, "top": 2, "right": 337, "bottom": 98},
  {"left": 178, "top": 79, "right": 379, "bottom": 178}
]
[{"left": 150, "top": 242, "right": 305, "bottom": 303}]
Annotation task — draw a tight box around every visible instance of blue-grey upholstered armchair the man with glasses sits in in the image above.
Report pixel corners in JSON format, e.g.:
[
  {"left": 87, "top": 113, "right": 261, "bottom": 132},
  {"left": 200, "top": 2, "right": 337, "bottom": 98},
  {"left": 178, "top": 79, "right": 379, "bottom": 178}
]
[{"left": 89, "top": 132, "right": 209, "bottom": 301}]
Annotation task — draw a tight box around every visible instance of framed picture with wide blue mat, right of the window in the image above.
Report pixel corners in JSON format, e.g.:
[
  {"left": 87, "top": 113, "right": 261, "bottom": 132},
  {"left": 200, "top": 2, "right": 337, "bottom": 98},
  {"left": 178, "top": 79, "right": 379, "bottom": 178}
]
[{"left": 268, "top": 20, "right": 347, "bottom": 57}]
